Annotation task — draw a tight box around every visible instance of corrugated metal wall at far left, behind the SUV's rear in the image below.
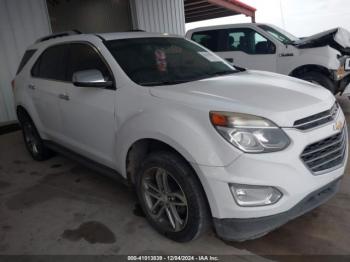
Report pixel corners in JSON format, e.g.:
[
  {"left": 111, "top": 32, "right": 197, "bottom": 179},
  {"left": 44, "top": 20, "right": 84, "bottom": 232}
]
[{"left": 0, "top": 0, "right": 51, "bottom": 124}]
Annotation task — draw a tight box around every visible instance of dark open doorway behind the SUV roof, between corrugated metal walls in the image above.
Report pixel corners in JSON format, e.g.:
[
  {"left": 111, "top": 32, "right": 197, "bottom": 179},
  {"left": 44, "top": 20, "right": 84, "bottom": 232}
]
[{"left": 47, "top": 0, "right": 132, "bottom": 33}]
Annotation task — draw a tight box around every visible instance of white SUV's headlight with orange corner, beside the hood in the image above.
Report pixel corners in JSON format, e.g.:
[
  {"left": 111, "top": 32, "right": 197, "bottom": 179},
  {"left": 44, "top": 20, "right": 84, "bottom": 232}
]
[{"left": 210, "top": 112, "right": 290, "bottom": 153}]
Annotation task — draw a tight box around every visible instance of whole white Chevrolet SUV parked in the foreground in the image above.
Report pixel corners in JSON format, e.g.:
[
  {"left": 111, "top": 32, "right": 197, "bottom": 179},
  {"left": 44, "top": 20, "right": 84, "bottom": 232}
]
[{"left": 13, "top": 32, "right": 347, "bottom": 241}]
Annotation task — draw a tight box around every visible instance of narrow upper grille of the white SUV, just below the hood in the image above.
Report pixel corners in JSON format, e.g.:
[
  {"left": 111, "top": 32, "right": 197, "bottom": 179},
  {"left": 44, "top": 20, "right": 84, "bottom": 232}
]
[{"left": 294, "top": 103, "right": 339, "bottom": 130}]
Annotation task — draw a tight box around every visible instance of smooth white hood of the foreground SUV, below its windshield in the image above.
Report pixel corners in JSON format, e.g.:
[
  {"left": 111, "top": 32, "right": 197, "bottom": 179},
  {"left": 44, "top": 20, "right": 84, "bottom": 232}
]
[{"left": 149, "top": 70, "right": 335, "bottom": 127}]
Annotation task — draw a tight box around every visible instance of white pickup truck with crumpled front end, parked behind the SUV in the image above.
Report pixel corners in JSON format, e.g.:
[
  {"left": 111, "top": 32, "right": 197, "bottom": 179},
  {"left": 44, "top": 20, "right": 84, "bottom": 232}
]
[{"left": 186, "top": 23, "right": 350, "bottom": 94}]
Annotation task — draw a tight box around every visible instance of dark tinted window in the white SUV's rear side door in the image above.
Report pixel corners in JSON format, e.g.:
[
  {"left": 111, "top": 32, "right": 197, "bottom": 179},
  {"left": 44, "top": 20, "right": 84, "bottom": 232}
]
[{"left": 32, "top": 45, "right": 67, "bottom": 81}]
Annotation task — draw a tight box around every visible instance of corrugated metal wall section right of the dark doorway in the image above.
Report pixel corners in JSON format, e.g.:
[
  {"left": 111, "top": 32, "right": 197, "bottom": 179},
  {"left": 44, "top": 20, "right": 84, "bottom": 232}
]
[{"left": 130, "top": 0, "right": 185, "bottom": 35}]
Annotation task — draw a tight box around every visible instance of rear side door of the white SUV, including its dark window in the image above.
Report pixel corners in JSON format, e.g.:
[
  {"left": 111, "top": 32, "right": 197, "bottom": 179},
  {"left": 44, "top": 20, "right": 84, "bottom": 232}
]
[{"left": 27, "top": 44, "right": 69, "bottom": 142}]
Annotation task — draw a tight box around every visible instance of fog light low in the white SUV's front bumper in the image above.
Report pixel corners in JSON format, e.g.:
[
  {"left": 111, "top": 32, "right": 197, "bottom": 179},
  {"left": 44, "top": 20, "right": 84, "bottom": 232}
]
[{"left": 230, "top": 184, "right": 283, "bottom": 207}]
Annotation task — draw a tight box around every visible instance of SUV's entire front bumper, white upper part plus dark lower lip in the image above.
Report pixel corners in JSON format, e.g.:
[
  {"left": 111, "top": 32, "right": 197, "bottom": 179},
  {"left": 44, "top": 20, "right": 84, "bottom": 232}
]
[{"left": 193, "top": 111, "right": 348, "bottom": 240}]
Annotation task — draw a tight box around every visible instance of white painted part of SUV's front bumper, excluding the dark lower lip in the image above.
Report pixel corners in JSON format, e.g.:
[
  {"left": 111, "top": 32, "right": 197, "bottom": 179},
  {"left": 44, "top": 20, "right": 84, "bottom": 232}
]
[{"left": 193, "top": 121, "right": 348, "bottom": 219}]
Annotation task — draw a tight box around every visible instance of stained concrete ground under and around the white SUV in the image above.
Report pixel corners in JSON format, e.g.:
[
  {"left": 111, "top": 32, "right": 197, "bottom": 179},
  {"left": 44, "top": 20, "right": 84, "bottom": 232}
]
[{"left": 0, "top": 99, "right": 350, "bottom": 256}]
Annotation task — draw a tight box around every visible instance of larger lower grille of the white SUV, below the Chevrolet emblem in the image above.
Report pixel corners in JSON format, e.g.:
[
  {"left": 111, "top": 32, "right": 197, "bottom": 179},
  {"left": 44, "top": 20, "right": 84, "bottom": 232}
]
[{"left": 301, "top": 127, "right": 347, "bottom": 174}]
